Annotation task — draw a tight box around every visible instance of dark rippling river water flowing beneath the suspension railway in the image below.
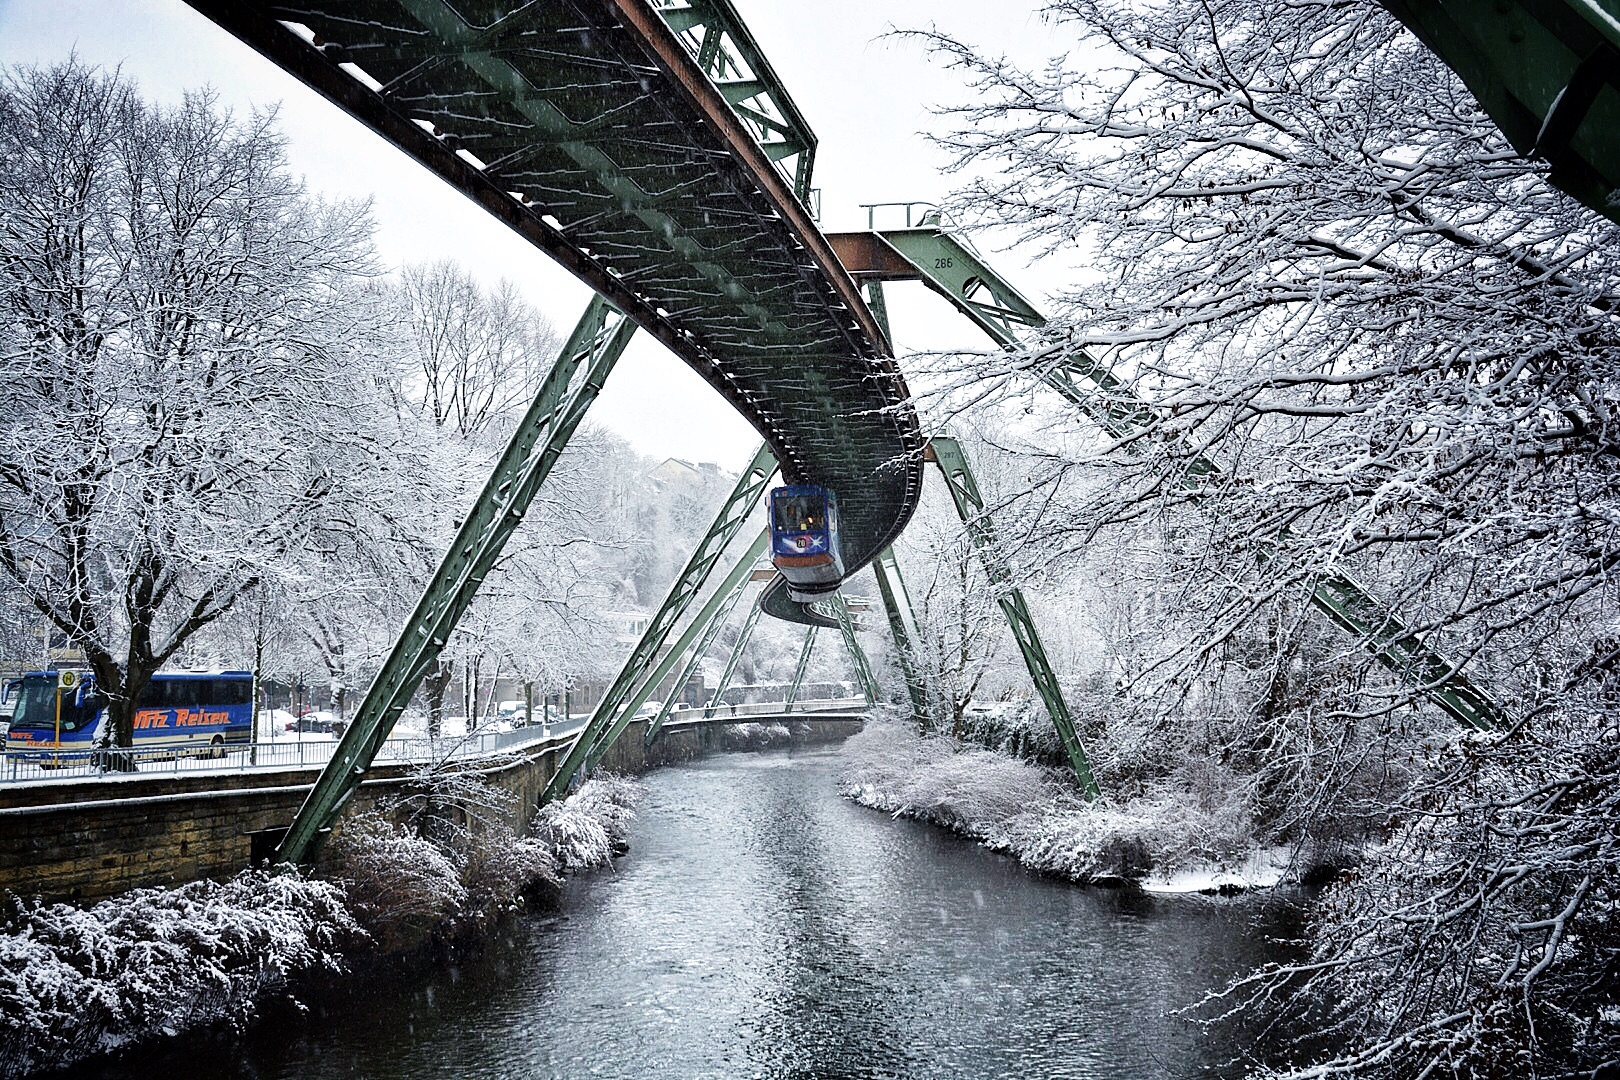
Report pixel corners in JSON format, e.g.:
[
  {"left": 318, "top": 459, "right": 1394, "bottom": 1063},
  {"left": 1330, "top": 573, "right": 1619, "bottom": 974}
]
[{"left": 85, "top": 748, "right": 1288, "bottom": 1080}]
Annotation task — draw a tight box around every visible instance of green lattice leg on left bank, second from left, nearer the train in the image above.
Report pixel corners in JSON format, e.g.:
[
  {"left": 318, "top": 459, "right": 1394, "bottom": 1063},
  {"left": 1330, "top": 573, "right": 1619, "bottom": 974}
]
[{"left": 541, "top": 445, "right": 776, "bottom": 801}]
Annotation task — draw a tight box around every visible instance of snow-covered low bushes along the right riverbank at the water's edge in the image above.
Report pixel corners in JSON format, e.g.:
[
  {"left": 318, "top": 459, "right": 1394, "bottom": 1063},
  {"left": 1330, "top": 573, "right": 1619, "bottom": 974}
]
[{"left": 839, "top": 722, "right": 1312, "bottom": 892}]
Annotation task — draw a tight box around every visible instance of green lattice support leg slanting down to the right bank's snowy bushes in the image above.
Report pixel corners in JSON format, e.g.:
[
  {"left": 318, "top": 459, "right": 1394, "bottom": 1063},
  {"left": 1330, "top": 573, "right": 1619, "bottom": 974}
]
[{"left": 928, "top": 436, "right": 1102, "bottom": 798}]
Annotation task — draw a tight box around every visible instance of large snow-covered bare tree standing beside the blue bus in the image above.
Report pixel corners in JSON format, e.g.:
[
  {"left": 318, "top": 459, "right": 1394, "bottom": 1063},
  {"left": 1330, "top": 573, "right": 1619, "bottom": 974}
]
[{"left": 0, "top": 62, "right": 387, "bottom": 745}]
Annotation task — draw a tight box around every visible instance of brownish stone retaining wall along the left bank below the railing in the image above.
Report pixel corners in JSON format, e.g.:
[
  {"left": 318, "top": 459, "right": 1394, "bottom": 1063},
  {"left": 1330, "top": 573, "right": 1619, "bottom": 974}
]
[{"left": 0, "top": 719, "right": 860, "bottom": 900}]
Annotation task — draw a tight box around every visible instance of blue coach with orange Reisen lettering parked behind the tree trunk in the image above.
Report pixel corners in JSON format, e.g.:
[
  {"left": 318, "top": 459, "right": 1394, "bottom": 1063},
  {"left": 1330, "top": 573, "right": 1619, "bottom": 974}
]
[{"left": 5, "top": 670, "right": 253, "bottom": 764}]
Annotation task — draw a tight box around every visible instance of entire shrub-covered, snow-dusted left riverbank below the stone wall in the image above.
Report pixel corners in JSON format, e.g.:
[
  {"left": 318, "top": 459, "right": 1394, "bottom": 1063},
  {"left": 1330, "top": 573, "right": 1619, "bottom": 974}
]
[{"left": 0, "top": 777, "right": 638, "bottom": 1080}]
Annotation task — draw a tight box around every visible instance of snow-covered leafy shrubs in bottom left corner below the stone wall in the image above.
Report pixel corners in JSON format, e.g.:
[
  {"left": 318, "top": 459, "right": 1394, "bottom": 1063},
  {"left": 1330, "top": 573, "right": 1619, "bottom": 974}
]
[{"left": 0, "top": 870, "right": 361, "bottom": 1077}]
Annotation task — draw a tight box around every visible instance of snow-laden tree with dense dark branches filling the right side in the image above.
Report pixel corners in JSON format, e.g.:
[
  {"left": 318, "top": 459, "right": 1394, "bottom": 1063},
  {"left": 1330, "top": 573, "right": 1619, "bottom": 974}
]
[{"left": 925, "top": 0, "right": 1620, "bottom": 1077}]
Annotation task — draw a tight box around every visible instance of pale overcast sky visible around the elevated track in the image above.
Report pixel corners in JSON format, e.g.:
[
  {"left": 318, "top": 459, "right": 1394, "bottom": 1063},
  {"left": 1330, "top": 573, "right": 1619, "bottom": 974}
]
[{"left": 0, "top": 0, "right": 1064, "bottom": 468}]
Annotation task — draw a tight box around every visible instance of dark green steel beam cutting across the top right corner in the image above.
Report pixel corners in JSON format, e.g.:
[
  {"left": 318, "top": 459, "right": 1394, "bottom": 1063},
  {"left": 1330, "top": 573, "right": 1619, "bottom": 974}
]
[{"left": 1382, "top": 0, "right": 1620, "bottom": 222}]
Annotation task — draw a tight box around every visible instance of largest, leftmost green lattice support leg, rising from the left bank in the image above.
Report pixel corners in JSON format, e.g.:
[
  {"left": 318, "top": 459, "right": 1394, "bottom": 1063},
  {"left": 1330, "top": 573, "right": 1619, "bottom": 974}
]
[{"left": 275, "top": 296, "right": 635, "bottom": 863}]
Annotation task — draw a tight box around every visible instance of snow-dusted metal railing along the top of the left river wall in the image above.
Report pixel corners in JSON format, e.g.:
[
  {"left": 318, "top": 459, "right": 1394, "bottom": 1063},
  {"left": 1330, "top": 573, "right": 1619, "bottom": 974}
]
[{"left": 0, "top": 698, "right": 867, "bottom": 784}]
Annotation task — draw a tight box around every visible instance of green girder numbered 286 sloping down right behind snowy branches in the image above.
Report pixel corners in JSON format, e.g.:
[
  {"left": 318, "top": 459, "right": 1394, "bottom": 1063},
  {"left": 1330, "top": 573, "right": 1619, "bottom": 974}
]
[{"left": 828, "top": 225, "right": 1503, "bottom": 729}]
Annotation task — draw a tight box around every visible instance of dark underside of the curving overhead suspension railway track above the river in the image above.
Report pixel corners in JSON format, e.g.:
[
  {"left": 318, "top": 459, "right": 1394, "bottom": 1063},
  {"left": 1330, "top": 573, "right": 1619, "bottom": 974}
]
[{"left": 190, "top": 0, "right": 923, "bottom": 641}]
